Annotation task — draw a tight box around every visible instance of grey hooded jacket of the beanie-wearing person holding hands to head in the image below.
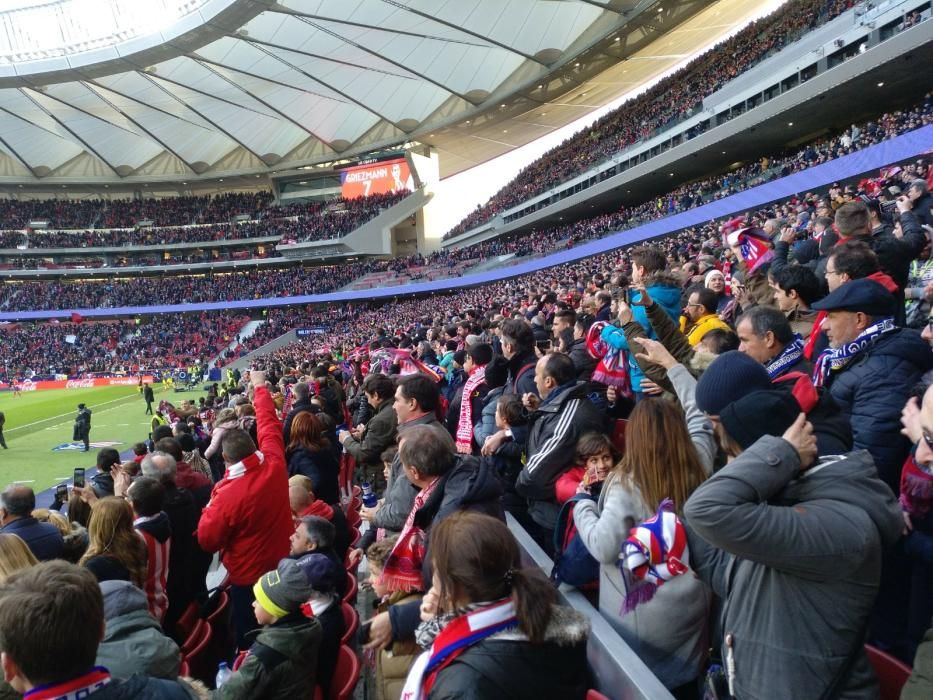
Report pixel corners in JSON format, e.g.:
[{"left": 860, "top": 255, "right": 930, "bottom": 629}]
[{"left": 684, "top": 435, "right": 903, "bottom": 700}]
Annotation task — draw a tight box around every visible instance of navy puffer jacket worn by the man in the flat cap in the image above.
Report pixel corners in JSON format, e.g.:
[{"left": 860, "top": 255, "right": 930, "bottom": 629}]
[{"left": 826, "top": 328, "right": 933, "bottom": 486}]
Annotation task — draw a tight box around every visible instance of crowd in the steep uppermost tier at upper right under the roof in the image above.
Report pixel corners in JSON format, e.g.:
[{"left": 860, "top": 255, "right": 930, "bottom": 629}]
[{"left": 445, "top": 0, "right": 888, "bottom": 238}]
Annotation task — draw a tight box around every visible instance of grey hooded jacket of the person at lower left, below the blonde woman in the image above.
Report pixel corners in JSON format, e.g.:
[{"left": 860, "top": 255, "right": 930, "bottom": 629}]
[{"left": 97, "top": 581, "right": 181, "bottom": 680}]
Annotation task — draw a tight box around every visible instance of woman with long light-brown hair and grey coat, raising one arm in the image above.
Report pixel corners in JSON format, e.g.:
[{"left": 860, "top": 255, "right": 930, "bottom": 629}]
[{"left": 573, "top": 339, "right": 716, "bottom": 698}]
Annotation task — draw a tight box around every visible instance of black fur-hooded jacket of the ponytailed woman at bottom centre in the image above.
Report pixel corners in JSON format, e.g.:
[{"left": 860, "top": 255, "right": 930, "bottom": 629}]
[{"left": 429, "top": 606, "right": 590, "bottom": 700}]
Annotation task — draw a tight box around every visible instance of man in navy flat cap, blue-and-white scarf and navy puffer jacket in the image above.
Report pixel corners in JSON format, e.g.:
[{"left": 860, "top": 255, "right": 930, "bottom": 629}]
[{"left": 813, "top": 279, "right": 933, "bottom": 486}]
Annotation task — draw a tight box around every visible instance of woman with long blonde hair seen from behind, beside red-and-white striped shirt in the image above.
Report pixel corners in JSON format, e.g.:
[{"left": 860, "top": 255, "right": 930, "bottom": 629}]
[{"left": 78, "top": 496, "right": 148, "bottom": 588}]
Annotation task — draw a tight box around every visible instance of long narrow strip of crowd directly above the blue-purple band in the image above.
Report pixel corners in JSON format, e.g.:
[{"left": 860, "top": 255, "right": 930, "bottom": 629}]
[{"left": 0, "top": 95, "right": 933, "bottom": 310}]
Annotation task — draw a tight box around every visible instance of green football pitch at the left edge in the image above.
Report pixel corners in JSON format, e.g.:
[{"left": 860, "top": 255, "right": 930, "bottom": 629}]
[{"left": 0, "top": 386, "right": 189, "bottom": 492}]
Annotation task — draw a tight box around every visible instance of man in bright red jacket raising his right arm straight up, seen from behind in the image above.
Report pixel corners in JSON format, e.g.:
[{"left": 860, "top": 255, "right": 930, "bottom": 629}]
[{"left": 198, "top": 371, "right": 294, "bottom": 649}]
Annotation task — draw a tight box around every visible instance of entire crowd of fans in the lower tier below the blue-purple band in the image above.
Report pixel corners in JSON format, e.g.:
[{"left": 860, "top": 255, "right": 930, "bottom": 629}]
[{"left": 0, "top": 160, "right": 933, "bottom": 700}]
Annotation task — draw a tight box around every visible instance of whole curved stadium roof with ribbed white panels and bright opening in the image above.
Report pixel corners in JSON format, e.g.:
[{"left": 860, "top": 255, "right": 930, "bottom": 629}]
[{"left": 0, "top": 0, "right": 755, "bottom": 184}]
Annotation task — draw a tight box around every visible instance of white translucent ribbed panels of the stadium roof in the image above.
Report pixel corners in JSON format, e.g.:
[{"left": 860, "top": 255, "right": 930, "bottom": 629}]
[{"left": 0, "top": 0, "right": 712, "bottom": 181}]
